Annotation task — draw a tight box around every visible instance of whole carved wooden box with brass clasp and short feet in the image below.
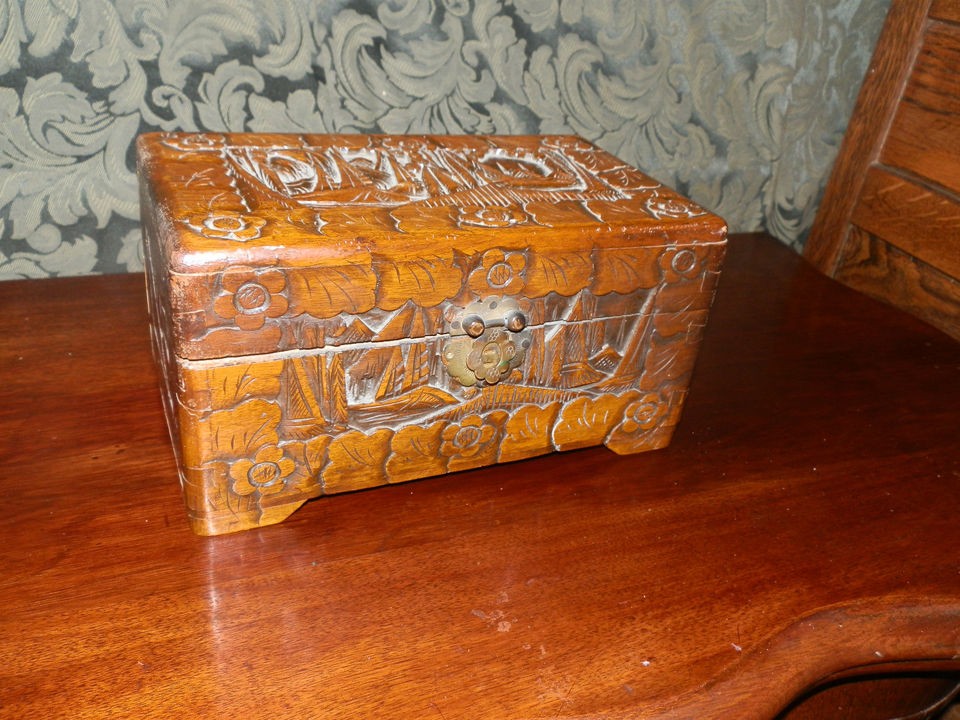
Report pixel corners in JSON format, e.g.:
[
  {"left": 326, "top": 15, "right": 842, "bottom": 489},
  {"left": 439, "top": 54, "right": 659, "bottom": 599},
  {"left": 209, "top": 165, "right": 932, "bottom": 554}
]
[{"left": 138, "top": 134, "right": 726, "bottom": 534}]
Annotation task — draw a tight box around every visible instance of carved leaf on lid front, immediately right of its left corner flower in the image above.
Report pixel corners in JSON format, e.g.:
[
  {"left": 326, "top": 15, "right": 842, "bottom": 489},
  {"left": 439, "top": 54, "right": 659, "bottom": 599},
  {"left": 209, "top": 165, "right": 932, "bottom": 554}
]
[{"left": 287, "top": 264, "right": 377, "bottom": 318}]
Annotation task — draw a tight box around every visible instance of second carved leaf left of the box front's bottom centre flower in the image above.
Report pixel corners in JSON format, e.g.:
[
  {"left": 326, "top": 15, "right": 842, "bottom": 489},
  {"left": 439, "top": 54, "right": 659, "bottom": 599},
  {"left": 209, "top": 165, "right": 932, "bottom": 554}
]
[{"left": 323, "top": 428, "right": 393, "bottom": 493}]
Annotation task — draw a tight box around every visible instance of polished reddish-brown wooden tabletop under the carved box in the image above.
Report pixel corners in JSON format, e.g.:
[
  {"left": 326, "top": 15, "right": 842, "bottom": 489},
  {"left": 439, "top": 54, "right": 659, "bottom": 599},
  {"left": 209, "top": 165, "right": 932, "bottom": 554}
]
[{"left": 0, "top": 236, "right": 960, "bottom": 720}]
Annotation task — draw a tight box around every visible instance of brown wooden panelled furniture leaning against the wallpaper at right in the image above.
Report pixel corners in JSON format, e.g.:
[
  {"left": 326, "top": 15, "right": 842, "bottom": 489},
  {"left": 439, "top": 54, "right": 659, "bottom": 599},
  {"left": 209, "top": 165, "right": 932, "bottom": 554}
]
[{"left": 804, "top": 0, "right": 960, "bottom": 339}]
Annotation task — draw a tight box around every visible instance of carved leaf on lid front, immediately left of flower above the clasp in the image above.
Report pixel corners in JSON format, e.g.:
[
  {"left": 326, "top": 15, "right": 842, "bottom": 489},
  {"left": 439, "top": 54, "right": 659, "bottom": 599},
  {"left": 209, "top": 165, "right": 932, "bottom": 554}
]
[{"left": 373, "top": 254, "right": 463, "bottom": 310}]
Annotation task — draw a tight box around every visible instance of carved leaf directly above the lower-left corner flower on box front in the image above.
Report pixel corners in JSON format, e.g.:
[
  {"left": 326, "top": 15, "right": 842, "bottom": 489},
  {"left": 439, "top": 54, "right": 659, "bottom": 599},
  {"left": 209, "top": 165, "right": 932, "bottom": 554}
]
[{"left": 192, "top": 399, "right": 280, "bottom": 465}]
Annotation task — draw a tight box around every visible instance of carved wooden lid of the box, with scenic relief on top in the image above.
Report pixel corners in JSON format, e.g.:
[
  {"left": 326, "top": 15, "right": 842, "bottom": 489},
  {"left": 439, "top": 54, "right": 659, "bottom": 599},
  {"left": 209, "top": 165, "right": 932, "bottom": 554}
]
[{"left": 138, "top": 133, "right": 726, "bottom": 359}]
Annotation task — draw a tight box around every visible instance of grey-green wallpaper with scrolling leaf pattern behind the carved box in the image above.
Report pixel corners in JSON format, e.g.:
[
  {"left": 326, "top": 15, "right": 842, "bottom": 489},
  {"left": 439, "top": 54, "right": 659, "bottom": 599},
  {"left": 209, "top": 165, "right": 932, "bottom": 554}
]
[{"left": 0, "top": 0, "right": 889, "bottom": 279}]
